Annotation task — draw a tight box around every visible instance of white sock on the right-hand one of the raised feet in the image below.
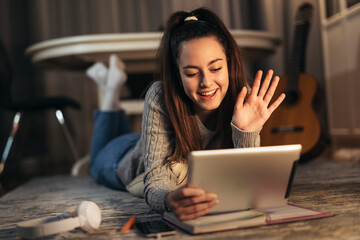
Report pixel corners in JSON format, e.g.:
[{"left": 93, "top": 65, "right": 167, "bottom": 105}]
[{"left": 100, "top": 54, "right": 127, "bottom": 111}]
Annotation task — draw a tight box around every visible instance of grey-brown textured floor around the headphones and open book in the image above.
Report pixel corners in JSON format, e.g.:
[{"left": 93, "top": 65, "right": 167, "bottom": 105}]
[{"left": 0, "top": 160, "right": 360, "bottom": 239}]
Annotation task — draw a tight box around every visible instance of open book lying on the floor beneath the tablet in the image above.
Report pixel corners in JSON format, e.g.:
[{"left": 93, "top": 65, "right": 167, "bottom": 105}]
[{"left": 163, "top": 205, "right": 333, "bottom": 234}]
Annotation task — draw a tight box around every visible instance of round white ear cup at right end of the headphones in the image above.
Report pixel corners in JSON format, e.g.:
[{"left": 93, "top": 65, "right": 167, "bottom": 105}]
[{"left": 76, "top": 201, "right": 101, "bottom": 232}]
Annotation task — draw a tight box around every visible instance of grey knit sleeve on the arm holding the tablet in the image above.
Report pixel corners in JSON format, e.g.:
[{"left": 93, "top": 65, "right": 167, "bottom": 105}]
[{"left": 142, "top": 82, "right": 177, "bottom": 212}]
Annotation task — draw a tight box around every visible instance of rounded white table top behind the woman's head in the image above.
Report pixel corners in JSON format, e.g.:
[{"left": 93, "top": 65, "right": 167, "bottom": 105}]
[{"left": 26, "top": 30, "right": 280, "bottom": 73}]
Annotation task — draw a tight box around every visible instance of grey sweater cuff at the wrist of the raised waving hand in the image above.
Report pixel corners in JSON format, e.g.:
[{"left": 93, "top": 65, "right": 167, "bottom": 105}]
[{"left": 231, "top": 122, "right": 261, "bottom": 148}]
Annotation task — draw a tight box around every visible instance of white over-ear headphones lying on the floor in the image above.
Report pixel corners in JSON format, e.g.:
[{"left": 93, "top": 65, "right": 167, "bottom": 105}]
[{"left": 16, "top": 201, "right": 101, "bottom": 238}]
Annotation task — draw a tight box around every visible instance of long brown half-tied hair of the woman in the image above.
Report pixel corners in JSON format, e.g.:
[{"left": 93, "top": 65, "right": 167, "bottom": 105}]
[{"left": 157, "top": 8, "right": 248, "bottom": 165}]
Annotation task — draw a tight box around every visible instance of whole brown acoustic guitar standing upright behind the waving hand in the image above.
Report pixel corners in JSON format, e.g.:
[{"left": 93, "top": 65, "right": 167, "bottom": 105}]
[{"left": 261, "top": 3, "right": 324, "bottom": 161}]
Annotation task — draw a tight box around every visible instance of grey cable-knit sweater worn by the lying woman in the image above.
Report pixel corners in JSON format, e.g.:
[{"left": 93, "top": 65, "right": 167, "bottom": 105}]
[{"left": 118, "top": 82, "right": 260, "bottom": 212}]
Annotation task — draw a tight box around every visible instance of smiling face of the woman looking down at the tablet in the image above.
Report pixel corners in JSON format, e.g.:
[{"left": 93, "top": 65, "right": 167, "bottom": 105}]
[{"left": 178, "top": 37, "right": 229, "bottom": 121}]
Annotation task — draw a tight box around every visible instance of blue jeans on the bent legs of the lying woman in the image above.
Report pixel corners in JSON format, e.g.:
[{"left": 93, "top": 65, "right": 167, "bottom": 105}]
[{"left": 90, "top": 111, "right": 140, "bottom": 191}]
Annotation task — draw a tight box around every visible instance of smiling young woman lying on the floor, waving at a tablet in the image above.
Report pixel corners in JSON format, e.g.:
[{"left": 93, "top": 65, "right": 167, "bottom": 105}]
[{"left": 87, "top": 8, "right": 285, "bottom": 220}]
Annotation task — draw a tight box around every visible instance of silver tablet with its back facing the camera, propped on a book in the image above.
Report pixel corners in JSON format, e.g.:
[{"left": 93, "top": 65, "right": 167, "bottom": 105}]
[{"left": 188, "top": 144, "right": 301, "bottom": 213}]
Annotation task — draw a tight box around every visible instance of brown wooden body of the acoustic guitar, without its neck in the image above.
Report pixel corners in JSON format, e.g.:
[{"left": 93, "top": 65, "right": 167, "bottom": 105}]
[{"left": 260, "top": 73, "right": 322, "bottom": 155}]
